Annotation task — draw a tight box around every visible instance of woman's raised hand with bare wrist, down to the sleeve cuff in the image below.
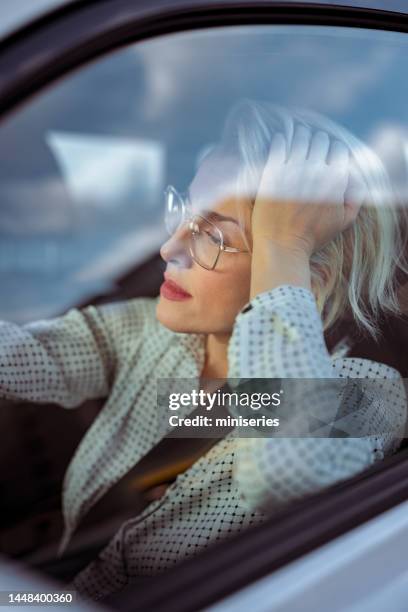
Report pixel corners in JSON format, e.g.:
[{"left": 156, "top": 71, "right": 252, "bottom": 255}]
[{"left": 250, "top": 126, "right": 365, "bottom": 299}]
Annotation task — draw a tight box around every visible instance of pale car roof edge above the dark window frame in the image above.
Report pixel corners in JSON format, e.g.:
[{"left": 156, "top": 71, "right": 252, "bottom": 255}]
[{"left": 0, "top": 0, "right": 408, "bottom": 38}]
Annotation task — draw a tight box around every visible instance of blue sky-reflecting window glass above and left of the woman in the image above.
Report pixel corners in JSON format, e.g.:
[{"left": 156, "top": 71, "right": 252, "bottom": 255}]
[{"left": 0, "top": 26, "right": 407, "bottom": 322}]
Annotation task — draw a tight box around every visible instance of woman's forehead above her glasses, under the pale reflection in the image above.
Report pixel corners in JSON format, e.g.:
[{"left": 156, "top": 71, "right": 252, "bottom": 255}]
[{"left": 189, "top": 152, "right": 250, "bottom": 219}]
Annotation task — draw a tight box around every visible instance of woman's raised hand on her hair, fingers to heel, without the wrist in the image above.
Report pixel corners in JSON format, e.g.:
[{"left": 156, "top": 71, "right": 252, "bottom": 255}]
[{"left": 252, "top": 126, "right": 361, "bottom": 257}]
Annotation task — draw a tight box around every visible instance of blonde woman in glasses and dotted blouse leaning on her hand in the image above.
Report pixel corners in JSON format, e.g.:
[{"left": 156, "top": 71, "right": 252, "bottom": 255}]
[{"left": 0, "top": 100, "right": 406, "bottom": 599}]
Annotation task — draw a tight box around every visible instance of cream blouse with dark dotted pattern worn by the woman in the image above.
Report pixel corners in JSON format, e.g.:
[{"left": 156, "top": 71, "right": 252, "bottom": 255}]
[{"left": 0, "top": 285, "right": 406, "bottom": 599}]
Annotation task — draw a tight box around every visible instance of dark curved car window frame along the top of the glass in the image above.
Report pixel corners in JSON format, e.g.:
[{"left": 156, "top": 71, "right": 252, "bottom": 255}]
[{"left": 0, "top": 0, "right": 408, "bottom": 121}]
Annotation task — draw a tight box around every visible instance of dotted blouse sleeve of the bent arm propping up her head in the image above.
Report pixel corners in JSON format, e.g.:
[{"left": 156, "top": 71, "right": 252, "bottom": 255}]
[{"left": 228, "top": 285, "right": 406, "bottom": 511}]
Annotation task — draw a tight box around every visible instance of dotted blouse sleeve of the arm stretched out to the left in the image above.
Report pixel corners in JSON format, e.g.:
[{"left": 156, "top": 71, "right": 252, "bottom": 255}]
[{"left": 0, "top": 298, "right": 149, "bottom": 408}]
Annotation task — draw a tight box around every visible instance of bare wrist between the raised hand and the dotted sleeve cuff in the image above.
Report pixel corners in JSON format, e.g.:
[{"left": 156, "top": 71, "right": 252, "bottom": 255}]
[{"left": 250, "top": 238, "right": 311, "bottom": 299}]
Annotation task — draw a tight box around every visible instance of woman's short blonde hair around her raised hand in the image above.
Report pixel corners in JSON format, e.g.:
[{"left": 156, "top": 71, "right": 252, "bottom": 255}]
[{"left": 218, "top": 98, "right": 408, "bottom": 340}]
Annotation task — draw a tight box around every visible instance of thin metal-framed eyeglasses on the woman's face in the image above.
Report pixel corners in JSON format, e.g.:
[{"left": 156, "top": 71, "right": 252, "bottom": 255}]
[{"left": 164, "top": 185, "right": 249, "bottom": 270}]
